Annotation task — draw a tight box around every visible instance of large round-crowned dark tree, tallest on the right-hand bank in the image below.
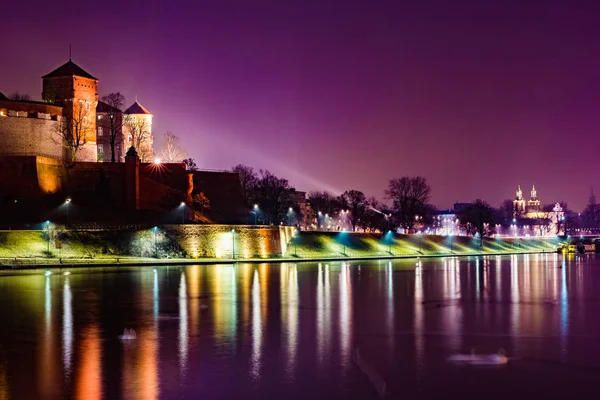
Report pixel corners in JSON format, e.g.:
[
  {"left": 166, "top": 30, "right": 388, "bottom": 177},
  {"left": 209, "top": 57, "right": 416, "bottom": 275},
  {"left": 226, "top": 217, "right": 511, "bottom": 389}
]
[{"left": 385, "top": 176, "right": 431, "bottom": 232}]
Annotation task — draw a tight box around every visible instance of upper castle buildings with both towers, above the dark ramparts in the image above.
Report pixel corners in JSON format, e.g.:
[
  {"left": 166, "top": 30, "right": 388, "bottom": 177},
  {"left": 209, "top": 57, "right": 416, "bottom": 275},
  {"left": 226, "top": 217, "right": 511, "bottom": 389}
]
[{"left": 0, "top": 60, "right": 153, "bottom": 162}]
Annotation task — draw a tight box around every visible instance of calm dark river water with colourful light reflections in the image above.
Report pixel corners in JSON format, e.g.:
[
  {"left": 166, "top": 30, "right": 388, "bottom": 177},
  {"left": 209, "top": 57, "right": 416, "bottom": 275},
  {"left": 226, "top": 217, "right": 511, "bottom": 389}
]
[{"left": 0, "top": 254, "right": 600, "bottom": 399}]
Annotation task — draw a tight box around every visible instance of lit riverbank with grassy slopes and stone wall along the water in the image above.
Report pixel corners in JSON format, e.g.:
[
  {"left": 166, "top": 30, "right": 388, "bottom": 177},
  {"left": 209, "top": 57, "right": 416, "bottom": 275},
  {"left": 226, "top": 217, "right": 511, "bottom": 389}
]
[{"left": 0, "top": 226, "right": 564, "bottom": 270}]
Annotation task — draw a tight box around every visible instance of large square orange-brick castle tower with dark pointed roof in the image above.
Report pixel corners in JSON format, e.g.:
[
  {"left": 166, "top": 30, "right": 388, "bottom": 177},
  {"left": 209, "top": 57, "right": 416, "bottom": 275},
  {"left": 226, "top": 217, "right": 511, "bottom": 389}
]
[{"left": 42, "top": 60, "right": 98, "bottom": 162}]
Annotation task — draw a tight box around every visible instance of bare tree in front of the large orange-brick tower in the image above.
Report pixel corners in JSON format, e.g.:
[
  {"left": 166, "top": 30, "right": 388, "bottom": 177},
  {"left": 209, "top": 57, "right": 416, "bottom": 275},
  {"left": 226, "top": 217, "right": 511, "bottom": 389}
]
[{"left": 53, "top": 101, "right": 95, "bottom": 163}]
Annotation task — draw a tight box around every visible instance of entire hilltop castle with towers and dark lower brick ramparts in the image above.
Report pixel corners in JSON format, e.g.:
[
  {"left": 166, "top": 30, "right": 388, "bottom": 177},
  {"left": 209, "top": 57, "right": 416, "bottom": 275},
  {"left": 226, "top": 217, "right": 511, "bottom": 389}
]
[{"left": 0, "top": 60, "right": 248, "bottom": 226}]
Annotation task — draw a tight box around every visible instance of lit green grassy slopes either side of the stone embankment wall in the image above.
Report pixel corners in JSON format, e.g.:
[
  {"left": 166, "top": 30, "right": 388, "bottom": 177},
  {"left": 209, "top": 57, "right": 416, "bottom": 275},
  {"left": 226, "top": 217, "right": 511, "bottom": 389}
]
[{"left": 0, "top": 231, "right": 561, "bottom": 259}]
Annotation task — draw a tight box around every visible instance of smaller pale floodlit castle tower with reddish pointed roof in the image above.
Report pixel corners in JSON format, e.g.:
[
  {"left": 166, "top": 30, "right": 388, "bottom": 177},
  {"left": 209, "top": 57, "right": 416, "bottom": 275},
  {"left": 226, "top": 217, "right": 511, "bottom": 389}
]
[{"left": 123, "top": 100, "right": 154, "bottom": 163}]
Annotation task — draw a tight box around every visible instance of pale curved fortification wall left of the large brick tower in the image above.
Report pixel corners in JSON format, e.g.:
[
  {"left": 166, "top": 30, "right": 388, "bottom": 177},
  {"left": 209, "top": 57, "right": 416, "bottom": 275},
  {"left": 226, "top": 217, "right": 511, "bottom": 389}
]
[{"left": 0, "top": 111, "right": 63, "bottom": 159}]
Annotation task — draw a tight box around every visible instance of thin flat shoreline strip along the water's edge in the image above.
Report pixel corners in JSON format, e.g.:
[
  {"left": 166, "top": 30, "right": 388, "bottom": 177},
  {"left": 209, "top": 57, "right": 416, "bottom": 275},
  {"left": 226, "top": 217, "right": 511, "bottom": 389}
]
[{"left": 0, "top": 251, "right": 557, "bottom": 271}]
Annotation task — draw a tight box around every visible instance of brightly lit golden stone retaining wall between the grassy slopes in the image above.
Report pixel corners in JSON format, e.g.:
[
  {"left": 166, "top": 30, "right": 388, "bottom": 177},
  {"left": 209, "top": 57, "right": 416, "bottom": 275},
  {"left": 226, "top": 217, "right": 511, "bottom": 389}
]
[{"left": 161, "top": 225, "right": 294, "bottom": 258}]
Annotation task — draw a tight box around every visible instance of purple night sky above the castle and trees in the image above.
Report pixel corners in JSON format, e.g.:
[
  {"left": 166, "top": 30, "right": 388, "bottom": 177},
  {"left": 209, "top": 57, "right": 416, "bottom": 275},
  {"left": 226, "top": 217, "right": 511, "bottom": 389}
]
[{"left": 0, "top": 0, "right": 600, "bottom": 209}]
